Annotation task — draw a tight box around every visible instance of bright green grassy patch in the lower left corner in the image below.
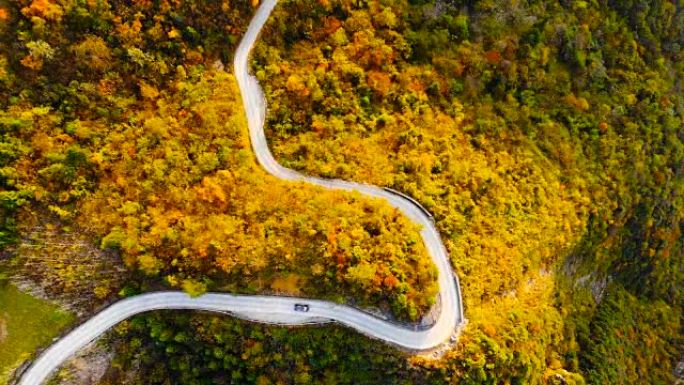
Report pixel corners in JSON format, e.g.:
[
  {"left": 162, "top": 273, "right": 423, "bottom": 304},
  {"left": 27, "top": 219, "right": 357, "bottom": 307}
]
[{"left": 0, "top": 280, "right": 74, "bottom": 384}]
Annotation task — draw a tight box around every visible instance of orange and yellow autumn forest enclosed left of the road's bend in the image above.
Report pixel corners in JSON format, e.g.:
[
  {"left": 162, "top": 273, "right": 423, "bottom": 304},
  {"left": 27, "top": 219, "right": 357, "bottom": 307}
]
[{"left": 0, "top": 0, "right": 438, "bottom": 320}]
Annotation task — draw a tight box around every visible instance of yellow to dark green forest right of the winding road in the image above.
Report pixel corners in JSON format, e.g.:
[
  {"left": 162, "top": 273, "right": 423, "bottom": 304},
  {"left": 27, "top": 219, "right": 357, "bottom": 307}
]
[{"left": 253, "top": 0, "right": 684, "bottom": 384}]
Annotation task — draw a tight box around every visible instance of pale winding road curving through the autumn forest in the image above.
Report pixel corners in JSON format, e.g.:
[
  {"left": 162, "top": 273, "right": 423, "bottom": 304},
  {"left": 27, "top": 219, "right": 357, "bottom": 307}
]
[{"left": 19, "top": 0, "right": 465, "bottom": 385}]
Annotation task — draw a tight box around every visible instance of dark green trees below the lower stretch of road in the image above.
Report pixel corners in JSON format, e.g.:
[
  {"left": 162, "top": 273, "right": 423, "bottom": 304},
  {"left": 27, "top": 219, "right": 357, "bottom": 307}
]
[{"left": 100, "top": 312, "right": 425, "bottom": 385}]
